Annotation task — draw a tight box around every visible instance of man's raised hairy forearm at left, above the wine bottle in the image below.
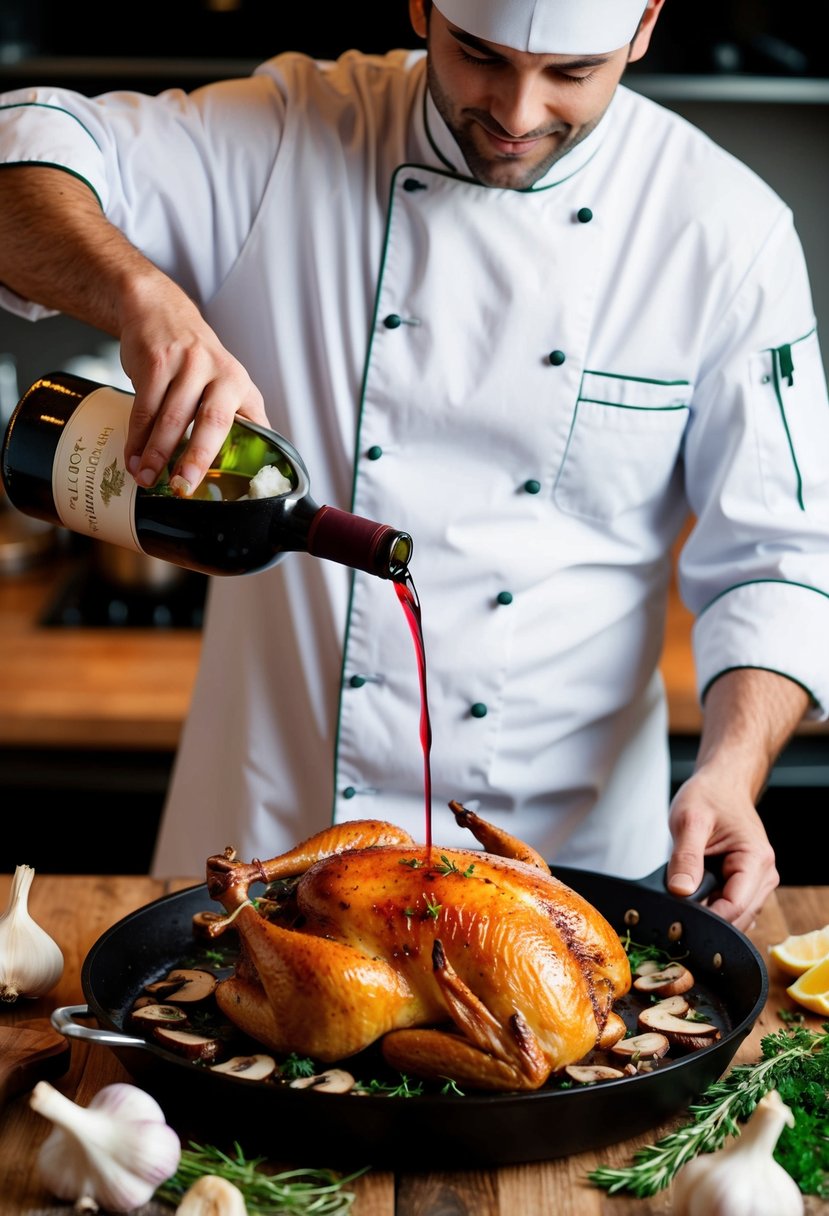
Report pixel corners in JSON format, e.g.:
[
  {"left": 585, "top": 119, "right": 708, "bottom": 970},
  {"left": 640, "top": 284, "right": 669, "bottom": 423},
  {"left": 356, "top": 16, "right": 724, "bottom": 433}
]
[{"left": 0, "top": 165, "right": 165, "bottom": 337}]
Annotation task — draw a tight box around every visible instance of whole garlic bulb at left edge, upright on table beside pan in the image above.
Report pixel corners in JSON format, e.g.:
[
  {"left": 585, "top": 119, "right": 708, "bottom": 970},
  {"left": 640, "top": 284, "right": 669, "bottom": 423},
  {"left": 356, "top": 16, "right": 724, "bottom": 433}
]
[{"left": 0, "top": 866, "right": 63, "bottom": 1002}]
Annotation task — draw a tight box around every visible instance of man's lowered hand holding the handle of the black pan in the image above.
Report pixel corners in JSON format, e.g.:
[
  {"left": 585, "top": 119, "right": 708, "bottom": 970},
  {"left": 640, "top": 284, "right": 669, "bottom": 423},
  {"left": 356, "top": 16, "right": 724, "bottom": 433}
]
[{"left": 667, "top": 769, "right": 780, "bottom": 933}]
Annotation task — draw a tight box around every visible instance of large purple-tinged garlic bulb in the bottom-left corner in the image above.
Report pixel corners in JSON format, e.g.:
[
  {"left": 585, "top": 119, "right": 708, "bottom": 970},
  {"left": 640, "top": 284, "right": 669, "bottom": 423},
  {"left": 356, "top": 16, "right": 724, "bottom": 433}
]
[{"left": 29, "top": 1081, "right": 181, "bottom": 1212}]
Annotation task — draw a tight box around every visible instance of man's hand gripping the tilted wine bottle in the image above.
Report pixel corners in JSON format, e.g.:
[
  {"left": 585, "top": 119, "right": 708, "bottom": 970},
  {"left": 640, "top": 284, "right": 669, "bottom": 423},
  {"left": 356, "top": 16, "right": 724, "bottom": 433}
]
[{"left": 120, "top": 268, "right": 269, "bottom": 492}]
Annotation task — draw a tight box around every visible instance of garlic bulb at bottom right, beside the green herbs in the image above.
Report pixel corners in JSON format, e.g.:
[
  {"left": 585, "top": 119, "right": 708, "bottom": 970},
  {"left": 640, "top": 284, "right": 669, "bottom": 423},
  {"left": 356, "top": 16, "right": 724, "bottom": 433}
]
[{"left": 672, "top": 1090, "right": 803, "bottom": 1216}]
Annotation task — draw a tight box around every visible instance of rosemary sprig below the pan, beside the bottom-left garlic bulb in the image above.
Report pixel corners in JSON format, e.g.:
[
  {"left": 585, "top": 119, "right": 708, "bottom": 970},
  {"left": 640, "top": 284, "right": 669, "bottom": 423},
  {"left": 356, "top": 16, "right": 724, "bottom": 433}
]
[{"left": 154, "top": 1141, "right": 368, "bottom": 1216}]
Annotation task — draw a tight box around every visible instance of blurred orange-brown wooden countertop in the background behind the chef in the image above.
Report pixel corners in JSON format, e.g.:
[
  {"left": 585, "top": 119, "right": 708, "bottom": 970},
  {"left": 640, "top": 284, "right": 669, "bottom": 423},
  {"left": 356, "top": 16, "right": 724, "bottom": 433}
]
[{"left": 0, "top": 549, "right": 827, "bottom": 750}]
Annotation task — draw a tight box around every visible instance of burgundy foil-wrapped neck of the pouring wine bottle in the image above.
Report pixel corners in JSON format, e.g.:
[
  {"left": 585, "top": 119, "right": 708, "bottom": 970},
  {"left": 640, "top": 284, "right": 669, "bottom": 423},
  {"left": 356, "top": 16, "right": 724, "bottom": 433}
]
[{"left": 308, "top": 507, "right": 412, "bottom": 581}]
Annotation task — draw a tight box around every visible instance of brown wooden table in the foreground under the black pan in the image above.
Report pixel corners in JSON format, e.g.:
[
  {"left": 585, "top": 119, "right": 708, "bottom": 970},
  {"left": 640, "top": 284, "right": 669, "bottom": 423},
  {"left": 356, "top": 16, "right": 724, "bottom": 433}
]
[{"left": 0, "top": 874, "right": 829, "bottom": 1216}]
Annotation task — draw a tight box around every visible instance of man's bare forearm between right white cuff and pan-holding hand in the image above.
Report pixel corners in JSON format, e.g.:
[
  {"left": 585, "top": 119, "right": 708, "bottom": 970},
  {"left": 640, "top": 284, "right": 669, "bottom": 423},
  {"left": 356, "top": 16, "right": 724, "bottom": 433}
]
[{"left": 695, "top": 668, "right": 810, "bottom": 801}]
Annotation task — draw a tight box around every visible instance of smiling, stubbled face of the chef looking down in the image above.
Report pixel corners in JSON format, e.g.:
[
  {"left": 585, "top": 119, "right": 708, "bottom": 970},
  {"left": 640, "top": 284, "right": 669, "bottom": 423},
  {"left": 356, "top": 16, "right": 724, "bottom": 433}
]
[{"left": 410, "top": 0, "right": 661, "bottom": 190}]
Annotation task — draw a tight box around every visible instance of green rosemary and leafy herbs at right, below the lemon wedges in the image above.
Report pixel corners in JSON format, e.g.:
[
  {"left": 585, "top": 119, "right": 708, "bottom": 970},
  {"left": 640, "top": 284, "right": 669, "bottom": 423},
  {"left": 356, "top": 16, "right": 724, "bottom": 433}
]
[{"left": 588, "top": 1023, "right": 829, "bottom": 1198}]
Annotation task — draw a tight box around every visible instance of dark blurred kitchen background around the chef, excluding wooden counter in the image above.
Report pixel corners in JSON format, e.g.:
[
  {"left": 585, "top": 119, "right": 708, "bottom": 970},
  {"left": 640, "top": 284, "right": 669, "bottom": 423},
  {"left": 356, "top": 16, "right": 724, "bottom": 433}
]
[{"left": 0, "top": 0, "right": 829, "bottom": 883}]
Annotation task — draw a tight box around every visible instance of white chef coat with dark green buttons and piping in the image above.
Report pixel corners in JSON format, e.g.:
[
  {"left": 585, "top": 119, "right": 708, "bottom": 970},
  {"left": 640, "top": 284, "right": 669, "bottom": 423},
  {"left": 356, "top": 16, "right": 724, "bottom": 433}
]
[{"left": 0, "top": 52, "right": 829, "bottom": 877}]
